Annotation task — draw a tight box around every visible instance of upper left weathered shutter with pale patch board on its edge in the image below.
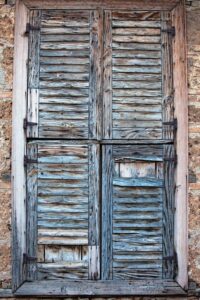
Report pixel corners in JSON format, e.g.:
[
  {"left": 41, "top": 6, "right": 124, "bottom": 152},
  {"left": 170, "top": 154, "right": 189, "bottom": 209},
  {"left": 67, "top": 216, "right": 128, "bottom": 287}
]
[{"left": 26, "top": 10, "right": 102, "bottom": 139}]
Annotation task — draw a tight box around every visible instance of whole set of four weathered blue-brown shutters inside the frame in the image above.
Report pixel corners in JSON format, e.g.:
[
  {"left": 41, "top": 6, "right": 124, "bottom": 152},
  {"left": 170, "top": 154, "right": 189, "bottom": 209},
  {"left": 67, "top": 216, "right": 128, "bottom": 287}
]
[{"left": 25, "top": 9, "right": 175, "bottom": 280}]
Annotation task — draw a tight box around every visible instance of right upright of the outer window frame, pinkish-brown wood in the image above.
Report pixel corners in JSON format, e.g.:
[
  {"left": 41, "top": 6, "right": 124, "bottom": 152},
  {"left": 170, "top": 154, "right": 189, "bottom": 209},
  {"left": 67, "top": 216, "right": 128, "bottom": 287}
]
[{"left": 172, "top": 0, "right": 188, "bottom": 288}]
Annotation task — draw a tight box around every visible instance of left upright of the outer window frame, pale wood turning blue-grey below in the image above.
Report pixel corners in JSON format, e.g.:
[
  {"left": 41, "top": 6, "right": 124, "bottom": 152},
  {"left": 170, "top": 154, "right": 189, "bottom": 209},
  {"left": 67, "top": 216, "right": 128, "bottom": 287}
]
[{"left": 12, "top": 0, "right": 29, "bottom": 292}]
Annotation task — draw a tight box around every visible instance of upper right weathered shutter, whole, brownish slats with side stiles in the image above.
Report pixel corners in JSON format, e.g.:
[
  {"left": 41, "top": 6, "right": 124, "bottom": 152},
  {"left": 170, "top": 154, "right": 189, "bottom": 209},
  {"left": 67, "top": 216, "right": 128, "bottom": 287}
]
[{"left": 103, "top": 11, "right": 173, "bottom": 140}]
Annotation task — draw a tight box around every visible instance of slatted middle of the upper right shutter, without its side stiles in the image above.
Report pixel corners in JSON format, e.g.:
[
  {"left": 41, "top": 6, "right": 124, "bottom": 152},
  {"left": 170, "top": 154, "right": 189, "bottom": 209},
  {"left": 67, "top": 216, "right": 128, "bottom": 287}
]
[{"left": 112, "top": 12, "right": 162, "bottom": 139}]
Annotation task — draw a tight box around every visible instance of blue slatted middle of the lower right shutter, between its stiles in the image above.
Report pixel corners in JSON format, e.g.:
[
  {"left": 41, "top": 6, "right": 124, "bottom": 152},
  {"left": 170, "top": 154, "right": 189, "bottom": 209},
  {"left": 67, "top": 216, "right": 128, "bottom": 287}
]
[{"left": 112, "top": 145, "right": 164, "bottom": 280}]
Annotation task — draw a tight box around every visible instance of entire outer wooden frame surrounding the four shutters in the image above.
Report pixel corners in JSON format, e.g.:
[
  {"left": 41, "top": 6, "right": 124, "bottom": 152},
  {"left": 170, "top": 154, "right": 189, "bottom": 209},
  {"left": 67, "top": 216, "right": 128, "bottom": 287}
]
[{"left": 12, "top": 0, "right": 188, "bottom": 297}]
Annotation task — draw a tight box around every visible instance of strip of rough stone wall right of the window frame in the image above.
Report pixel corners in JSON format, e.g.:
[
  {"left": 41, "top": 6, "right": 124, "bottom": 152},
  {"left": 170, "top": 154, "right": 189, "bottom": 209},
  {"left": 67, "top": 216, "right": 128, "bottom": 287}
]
[{"left": 187, "top": 0, "right": 200, "bottom": 284}]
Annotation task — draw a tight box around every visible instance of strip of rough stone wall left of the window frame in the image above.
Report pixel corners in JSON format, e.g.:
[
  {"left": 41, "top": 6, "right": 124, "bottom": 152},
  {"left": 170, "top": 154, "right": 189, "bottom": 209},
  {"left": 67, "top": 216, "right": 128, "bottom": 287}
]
[{"left": 0, "top": 0, "right": 14, "bottom": 288}]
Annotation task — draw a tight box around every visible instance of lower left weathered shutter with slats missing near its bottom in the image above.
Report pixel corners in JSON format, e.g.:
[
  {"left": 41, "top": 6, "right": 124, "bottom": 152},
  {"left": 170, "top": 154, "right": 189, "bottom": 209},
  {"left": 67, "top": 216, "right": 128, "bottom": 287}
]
[{"left": 26, "top": 141, "right": 99, "bottom": 279}]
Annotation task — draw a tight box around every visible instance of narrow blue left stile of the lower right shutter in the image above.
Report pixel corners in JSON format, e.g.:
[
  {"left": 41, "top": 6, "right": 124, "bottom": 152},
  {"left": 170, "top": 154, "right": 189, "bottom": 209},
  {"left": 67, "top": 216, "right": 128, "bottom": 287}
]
[{"left": 101, "top": 145, "right": 113, "bottom": 280}]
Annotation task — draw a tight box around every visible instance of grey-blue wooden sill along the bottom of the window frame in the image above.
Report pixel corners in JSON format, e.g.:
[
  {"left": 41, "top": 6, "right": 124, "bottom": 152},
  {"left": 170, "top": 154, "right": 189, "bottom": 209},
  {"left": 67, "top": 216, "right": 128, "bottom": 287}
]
[{"left": 14, "top": 280, "right": 186, "bottom": 297}]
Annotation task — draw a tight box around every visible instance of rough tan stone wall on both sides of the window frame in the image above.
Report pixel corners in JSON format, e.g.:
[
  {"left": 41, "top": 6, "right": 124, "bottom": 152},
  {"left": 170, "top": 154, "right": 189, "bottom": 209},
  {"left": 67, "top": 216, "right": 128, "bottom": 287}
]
[{"left": 0, "top": 0, "right": 200, "bottom": 300}]
